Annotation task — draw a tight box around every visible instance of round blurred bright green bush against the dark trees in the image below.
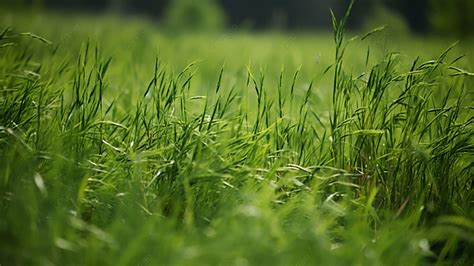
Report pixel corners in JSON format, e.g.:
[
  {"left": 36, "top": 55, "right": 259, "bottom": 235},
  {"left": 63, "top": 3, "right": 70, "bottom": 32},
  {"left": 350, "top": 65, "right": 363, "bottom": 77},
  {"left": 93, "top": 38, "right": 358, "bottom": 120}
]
[{"left": 164, "top": 0, "right": 226, "bottom": 31}]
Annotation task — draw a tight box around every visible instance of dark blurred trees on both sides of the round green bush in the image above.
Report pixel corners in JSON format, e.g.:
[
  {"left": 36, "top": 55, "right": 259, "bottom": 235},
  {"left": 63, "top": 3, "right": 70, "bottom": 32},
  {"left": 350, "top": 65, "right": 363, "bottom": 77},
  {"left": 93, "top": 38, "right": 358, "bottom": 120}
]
[{"left": 0, "top": 0, "right": 474, "bottom": 35}]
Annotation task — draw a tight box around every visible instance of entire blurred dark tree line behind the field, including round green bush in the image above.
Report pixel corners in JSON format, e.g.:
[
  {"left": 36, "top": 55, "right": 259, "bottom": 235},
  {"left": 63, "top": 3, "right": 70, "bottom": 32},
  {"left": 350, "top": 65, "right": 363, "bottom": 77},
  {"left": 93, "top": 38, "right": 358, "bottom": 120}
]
[{"left": 3, "top": 0, "right": 474, "bottom": 36}]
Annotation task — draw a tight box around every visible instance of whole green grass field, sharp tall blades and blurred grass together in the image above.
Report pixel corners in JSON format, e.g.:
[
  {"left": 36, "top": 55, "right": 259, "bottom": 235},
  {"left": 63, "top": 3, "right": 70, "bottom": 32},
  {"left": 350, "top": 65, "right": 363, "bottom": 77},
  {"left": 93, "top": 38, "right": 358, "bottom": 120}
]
[{"left": 0, "top": 6, "right": 474, "bottom": 265}]
